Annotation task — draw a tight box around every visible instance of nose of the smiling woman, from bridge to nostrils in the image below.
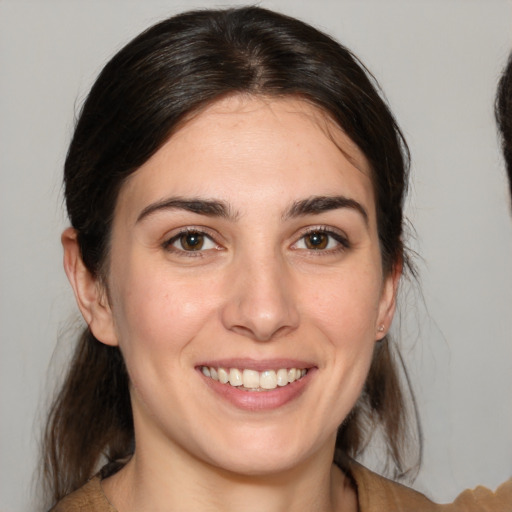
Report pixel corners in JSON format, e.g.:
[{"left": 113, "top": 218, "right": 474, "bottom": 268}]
[{"left": 222, "top": 251, "right": 299, "bottom": 341}]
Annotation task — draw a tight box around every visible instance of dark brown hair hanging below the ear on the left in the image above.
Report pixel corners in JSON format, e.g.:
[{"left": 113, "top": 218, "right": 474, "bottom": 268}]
[{"left": 43, "top": 329, "right": 134, "bottom": 503}]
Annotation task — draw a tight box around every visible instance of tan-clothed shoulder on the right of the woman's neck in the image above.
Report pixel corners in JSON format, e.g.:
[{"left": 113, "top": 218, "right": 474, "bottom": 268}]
[{"left": 349, "top": 463, "right": 512, "bottom": 512}]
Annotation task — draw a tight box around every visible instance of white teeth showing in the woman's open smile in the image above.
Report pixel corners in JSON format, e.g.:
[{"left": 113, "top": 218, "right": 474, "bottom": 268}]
[{"left": 200, "top": 366, "right": 308, "bottom": 391}]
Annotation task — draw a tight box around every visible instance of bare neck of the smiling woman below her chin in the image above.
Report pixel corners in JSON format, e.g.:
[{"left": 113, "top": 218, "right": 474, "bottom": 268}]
[{"left": 103, "top": 436, "right": 357, "bottom": 512}]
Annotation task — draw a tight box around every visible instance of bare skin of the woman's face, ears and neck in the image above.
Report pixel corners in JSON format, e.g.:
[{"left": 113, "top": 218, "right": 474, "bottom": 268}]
[{"left": 62, "top": 96, "right": 399, "bottom": 512}]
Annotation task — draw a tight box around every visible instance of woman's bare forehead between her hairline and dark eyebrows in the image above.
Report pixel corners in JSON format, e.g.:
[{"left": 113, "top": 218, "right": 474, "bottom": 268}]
[{"left": 114, "top": 96, "right": 374, "bottom": 222}]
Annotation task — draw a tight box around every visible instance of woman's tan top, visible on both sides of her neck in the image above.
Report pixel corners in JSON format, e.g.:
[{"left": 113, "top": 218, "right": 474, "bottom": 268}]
[{"left": 50, "top": 464, "right": 512, "bottom": 512}]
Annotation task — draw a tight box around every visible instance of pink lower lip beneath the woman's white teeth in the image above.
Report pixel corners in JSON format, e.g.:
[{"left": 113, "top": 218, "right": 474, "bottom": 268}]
[{"left": 198, "top": 368, "right": 315, "bottom": 411}]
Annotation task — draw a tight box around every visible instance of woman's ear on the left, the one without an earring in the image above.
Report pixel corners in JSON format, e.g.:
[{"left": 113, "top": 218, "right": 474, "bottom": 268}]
[{"left": 61, "top": 228, "right": 118, "bottom": 346}]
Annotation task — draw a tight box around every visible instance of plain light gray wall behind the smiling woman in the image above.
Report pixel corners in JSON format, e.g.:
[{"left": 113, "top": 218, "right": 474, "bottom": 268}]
[{"left": 0, "top": 0, "right": 512, "bottom": 512}]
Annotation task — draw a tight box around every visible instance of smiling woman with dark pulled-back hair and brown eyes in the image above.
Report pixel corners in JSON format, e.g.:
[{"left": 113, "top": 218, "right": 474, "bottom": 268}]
[{"left": 46, "top": 8, "right": 508, "bottom": 512}]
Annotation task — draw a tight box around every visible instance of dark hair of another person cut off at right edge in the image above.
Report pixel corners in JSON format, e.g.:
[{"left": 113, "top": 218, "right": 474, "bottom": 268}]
[{"left": 494, "top": 53, "right": 512, "bottom": 199}]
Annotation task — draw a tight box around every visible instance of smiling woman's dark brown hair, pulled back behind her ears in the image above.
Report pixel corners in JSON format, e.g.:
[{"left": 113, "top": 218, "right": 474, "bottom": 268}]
[{"left": 43, "top": 7, "right": 417, "bottom": 502}]
